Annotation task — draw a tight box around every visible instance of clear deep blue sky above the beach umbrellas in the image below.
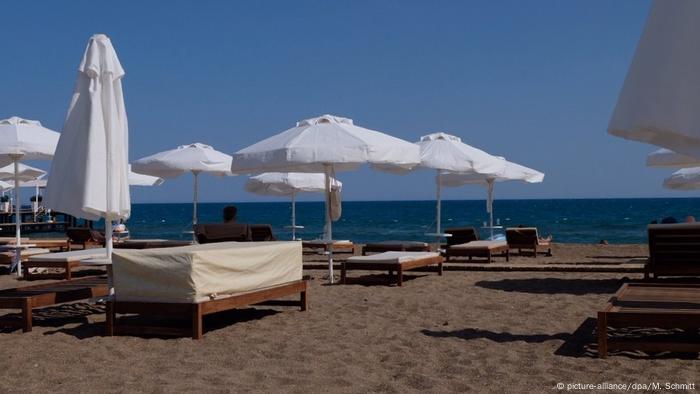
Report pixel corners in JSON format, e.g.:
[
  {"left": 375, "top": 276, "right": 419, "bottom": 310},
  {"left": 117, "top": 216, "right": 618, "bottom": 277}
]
[{"left": 0, "top": 0, "right": 676, "bottom": 202}]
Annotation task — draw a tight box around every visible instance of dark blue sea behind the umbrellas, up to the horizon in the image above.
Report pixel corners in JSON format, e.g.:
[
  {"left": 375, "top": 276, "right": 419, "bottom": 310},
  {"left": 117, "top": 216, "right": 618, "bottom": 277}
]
[{"left": 121, "top": 198, "right": 700, "bottom": 243}]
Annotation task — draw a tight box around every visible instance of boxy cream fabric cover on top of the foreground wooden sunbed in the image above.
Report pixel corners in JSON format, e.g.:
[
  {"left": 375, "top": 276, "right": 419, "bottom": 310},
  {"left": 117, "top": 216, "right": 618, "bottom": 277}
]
[{"left": 112, "top": 242, "right": 302, "bottom": 303}]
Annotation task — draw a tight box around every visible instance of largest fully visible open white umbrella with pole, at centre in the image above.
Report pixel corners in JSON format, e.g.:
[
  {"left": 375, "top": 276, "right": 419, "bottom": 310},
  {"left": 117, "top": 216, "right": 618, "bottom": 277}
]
[{"left": 231, "top": 115, "right": 420, "bottom": 283}]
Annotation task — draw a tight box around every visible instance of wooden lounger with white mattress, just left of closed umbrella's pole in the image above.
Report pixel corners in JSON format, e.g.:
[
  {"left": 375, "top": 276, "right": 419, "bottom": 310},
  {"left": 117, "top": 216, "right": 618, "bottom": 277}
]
[{"left": 22, "top": 248, "right": 107, "bottom": 280}]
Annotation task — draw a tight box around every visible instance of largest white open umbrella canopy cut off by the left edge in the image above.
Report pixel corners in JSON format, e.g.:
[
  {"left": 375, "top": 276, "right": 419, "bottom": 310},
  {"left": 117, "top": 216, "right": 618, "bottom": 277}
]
[{"left": 0, "top": 116, "right": 60, "bottom": 166}]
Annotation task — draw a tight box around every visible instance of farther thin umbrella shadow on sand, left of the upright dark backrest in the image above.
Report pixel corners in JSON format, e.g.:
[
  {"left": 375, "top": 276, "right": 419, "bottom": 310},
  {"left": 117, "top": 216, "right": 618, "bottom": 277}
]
[{"left": 475, "top": 278, "right": 628, "bottom": 295}]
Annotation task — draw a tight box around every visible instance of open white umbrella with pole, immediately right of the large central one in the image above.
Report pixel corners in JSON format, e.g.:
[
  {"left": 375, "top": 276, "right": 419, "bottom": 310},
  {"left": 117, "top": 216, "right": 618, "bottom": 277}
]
[{"left": 416, "top": 133, "right": 505, "bottom": 245}]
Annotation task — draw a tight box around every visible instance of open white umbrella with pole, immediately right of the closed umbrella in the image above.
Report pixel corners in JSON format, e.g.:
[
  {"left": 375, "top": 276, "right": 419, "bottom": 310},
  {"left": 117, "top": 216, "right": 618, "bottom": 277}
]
[{"left": 131, "top": 142, "right": 231, "bottom": 241}]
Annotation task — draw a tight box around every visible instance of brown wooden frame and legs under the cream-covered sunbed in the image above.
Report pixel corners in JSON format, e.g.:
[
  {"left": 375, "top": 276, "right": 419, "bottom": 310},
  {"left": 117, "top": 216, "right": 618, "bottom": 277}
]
[{"left": 105, "top": 279, "right": 308, "bottom": 339}]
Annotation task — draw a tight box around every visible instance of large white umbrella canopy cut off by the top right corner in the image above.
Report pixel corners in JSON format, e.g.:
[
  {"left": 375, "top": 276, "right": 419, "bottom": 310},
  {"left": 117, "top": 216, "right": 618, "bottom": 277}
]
[{"left": 608, "top": 0, "right": 700, "bottom": 157}]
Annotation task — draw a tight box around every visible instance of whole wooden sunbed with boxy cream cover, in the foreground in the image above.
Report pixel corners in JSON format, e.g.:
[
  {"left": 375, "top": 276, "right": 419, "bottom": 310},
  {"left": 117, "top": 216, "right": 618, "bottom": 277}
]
[{"left": 106, "top": 242, "right": 307, "bottom": 339}]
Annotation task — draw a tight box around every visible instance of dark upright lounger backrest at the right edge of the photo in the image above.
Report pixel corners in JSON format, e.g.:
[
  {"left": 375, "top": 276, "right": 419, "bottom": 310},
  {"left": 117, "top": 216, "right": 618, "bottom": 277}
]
[{"left": 644, "top": 223, "right": 700, "bottom": 278}]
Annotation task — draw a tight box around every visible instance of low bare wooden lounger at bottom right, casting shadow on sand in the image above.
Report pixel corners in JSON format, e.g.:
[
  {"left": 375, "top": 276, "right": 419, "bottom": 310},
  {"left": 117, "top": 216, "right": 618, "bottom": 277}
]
[{"left": 598, "top": 283, "right": 700, "bottom": 358}]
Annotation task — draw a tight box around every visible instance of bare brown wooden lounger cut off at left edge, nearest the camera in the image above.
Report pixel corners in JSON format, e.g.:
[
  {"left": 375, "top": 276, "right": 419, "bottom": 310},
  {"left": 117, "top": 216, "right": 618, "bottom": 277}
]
[{"left": 0, "top": 277, "right": 109, "bottom": 332}]
